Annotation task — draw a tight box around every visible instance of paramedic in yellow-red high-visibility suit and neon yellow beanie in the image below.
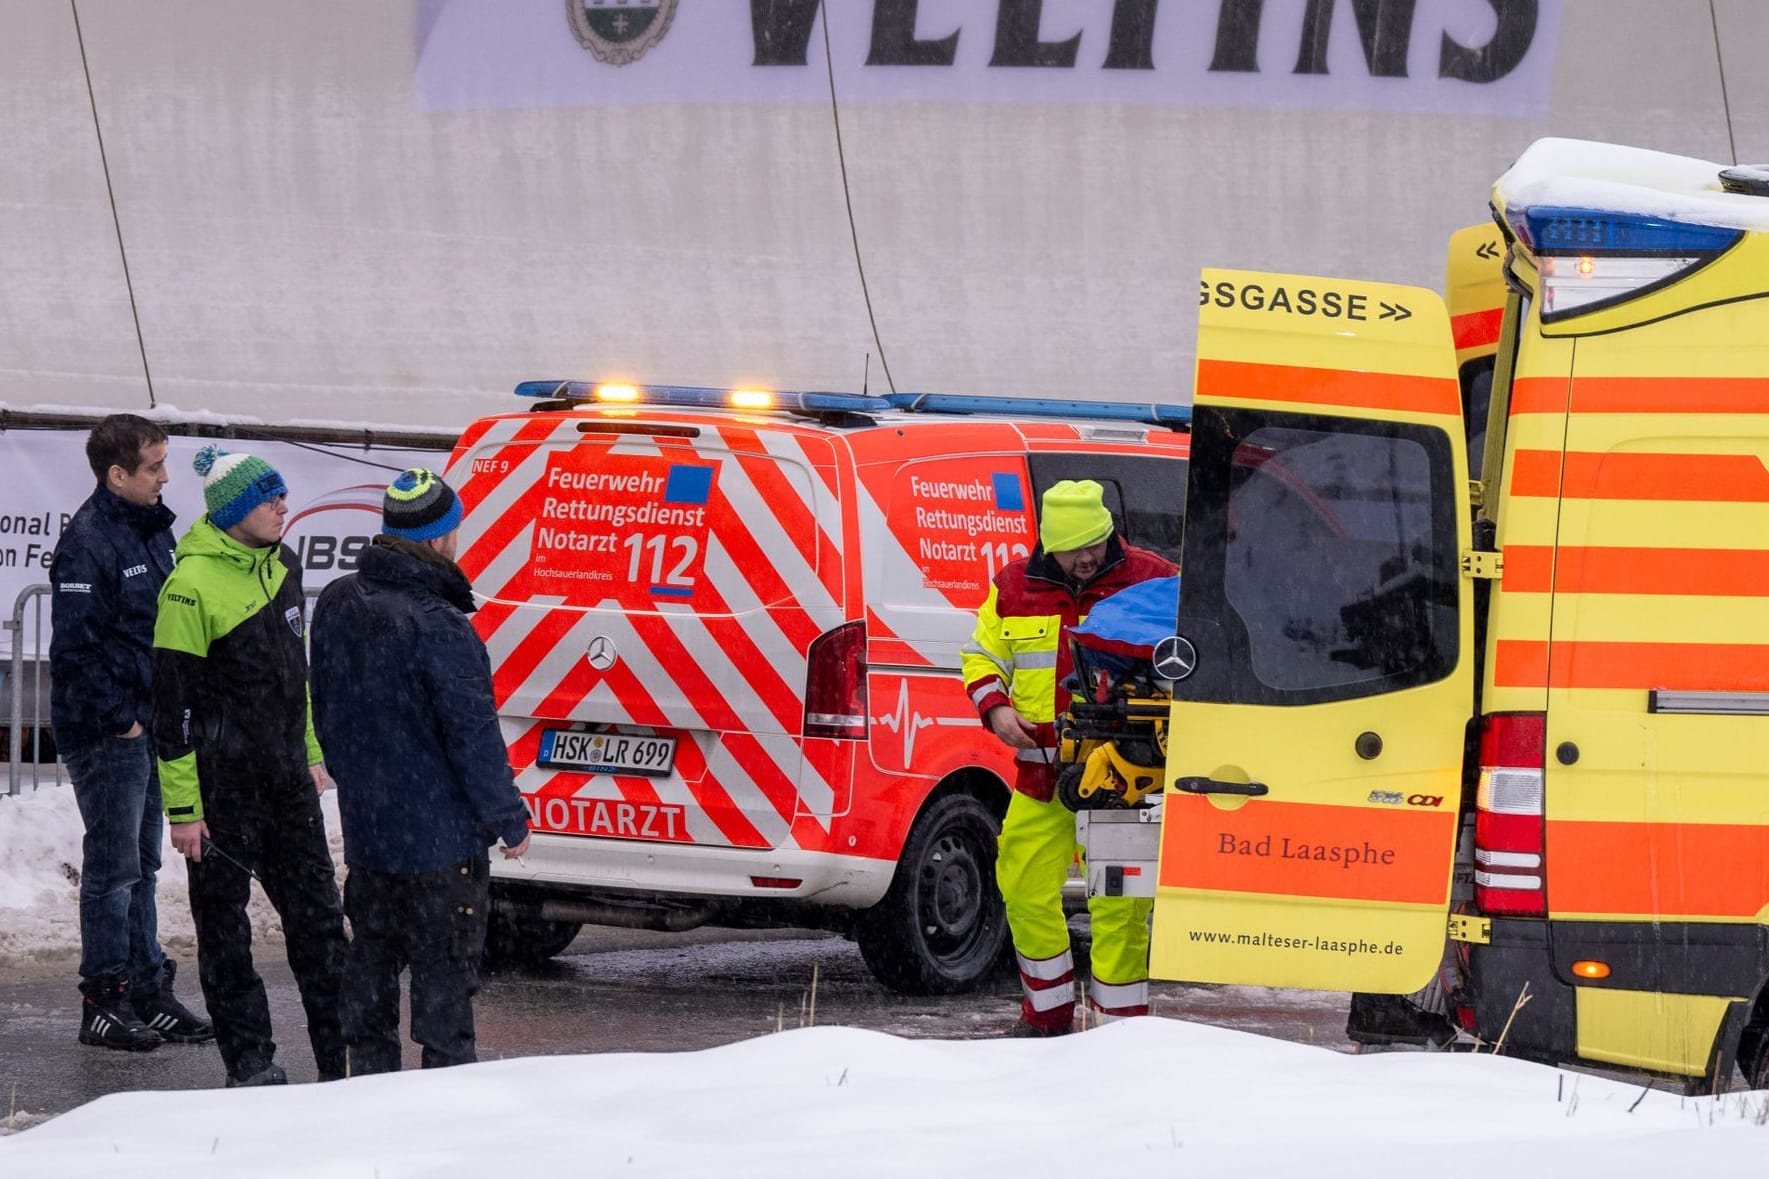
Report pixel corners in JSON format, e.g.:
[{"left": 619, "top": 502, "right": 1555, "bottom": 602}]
[{"left": 964, "top": 480, "right": 1178, "bottom": 1036}]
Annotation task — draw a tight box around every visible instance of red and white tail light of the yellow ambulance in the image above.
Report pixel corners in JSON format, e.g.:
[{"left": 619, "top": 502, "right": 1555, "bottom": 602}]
[{"left": 1474, "top": 712, "right": 1548, "bottom": 917}]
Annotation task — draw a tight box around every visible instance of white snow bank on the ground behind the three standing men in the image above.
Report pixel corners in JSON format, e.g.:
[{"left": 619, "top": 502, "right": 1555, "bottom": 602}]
[{"left": 0, "top": 777, "right": 343, "bottom": 977}]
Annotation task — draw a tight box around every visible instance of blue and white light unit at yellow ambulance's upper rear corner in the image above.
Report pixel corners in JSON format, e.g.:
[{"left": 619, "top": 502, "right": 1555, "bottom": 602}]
[{"left": 1507, "top": 207, "right": 1744, "bottom": 324}]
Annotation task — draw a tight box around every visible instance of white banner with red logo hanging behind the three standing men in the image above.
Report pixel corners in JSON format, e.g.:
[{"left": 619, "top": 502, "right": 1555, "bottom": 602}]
[{"left": 0, "top": 430, "right": 449, "bottom": 655}]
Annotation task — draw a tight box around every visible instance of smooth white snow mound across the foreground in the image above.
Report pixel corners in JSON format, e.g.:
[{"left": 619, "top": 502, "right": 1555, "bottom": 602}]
[{"left": 0, "top": 1018, "right": 1769, "bottom": 1179}]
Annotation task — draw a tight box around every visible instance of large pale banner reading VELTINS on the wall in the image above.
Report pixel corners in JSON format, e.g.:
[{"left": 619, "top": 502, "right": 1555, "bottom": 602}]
[{"left": 416, "top": 0, "right": 1562, "bottom": 115}]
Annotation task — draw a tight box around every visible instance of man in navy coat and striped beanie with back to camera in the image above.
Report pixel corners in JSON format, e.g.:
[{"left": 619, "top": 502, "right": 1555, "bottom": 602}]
[{"left": 313, "top": 469, "right": 529, "bottom": 1075}]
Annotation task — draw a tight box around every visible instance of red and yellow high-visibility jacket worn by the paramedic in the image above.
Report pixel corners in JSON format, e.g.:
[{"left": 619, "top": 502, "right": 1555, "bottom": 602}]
[{"left": 964, "top": 536, "right": 1178, "bottom": 802}]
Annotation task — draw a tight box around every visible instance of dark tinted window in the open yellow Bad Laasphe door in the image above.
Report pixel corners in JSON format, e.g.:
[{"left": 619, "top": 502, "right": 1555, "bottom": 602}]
[{"left": 1182, "top": 411, "right": 1459, "bottom": 705}]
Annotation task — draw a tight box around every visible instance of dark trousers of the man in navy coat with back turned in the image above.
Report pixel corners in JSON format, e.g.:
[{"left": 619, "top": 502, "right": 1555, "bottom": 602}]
[{"left": 343, "top": 853, "right": 492, "bottom": 1076}]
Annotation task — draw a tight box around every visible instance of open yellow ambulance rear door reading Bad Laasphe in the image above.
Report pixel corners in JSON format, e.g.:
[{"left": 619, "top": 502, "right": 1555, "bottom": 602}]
[{"left": 1152, "top": 271, "right": 1484, "bottom": 993}]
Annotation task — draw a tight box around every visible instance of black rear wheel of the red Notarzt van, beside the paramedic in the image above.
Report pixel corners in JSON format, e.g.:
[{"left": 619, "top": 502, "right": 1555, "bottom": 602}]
[{"left": 854, "top": 793, "right": 1008, "bottom": 995}]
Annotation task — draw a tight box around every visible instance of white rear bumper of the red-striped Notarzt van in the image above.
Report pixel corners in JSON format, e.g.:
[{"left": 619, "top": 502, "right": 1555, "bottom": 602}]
[{"left": 492, "top": 832, "right": 897, "bottom": 908}]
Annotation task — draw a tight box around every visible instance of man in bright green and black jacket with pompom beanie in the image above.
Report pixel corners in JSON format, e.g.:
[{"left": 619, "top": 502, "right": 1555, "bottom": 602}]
[{"left": 154, "top": 446, "right": 345, "bottom": 1085}]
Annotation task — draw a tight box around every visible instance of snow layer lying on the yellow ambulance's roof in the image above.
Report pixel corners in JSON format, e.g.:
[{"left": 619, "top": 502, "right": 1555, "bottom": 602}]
[{"left": 1493, "top": 138, "right": 1769, "bottom": 232}]
